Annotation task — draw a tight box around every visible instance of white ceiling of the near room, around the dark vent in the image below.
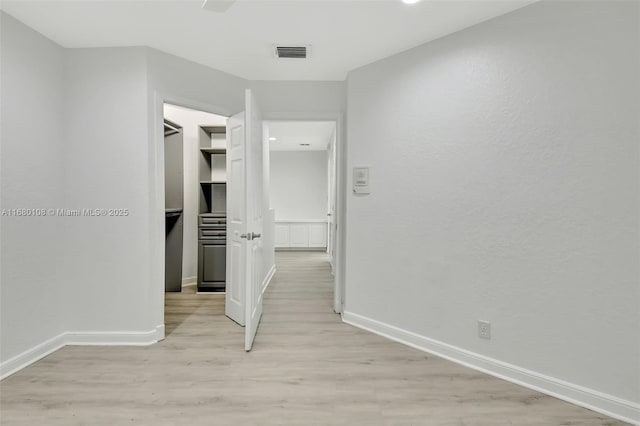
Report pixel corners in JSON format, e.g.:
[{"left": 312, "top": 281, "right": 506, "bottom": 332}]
[{"left": 0, "top": 0, "right": 533, "bottom": 80}]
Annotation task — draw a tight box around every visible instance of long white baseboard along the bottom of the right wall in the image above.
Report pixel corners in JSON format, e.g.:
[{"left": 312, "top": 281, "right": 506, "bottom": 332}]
[{"left": 342, "top": 312, "right": 640, "bottom": 425}]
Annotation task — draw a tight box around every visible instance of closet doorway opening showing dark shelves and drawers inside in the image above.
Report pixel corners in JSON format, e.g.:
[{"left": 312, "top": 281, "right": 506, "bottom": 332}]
[{"left": 163, "top": 102, "right": 227, "bottom": 335}]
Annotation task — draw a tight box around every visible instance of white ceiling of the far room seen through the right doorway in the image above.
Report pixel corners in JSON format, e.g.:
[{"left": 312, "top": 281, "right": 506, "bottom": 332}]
[{"left": 267, "top": 121, "right": 335, "bottom": 151}]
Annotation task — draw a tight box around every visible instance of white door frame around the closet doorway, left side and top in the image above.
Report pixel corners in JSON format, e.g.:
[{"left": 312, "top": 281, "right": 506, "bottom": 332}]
[{"left": 149, "top": 91, "right": 238, "bottom": 341}]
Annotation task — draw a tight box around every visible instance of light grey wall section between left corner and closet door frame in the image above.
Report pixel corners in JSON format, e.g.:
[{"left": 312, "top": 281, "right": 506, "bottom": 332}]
[{"left": 64, "top": 48, "right": 157, "bottom": 333}]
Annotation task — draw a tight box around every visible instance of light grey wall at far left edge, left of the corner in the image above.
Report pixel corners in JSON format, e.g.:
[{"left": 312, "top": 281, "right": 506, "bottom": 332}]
[{"left": 0, "top": 12, "right": 69, "bottom": 362}]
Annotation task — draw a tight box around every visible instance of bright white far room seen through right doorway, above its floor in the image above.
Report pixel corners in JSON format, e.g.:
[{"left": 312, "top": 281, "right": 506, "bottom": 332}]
[{"left": 264, "top": 121, "right": 338, "bottom": 310}]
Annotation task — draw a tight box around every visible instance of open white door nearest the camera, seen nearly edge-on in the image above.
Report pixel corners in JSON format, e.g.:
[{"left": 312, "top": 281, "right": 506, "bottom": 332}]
[{"left": 244, "top": 89, "right": 264, "bottom": 351}]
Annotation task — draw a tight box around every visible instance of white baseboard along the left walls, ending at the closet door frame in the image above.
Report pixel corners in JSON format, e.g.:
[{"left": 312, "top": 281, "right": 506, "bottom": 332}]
[{"left": 0, "top": 324, "right": 164, "bottom": 380}]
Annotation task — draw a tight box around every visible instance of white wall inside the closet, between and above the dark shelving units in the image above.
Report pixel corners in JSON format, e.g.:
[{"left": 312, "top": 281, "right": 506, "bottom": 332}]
[{"left": 164, "top": 104, "right": 227, "bottom": 282}]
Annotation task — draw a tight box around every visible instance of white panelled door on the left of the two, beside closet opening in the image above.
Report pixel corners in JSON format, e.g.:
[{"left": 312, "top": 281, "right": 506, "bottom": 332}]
[{"left": 224, "top": 112, "right": 247, "bottom": 325}]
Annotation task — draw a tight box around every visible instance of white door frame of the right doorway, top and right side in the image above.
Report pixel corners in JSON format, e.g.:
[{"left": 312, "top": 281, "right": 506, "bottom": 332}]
[{"left": 262, "top": 112, "right": 347, "bottom": 314}]
